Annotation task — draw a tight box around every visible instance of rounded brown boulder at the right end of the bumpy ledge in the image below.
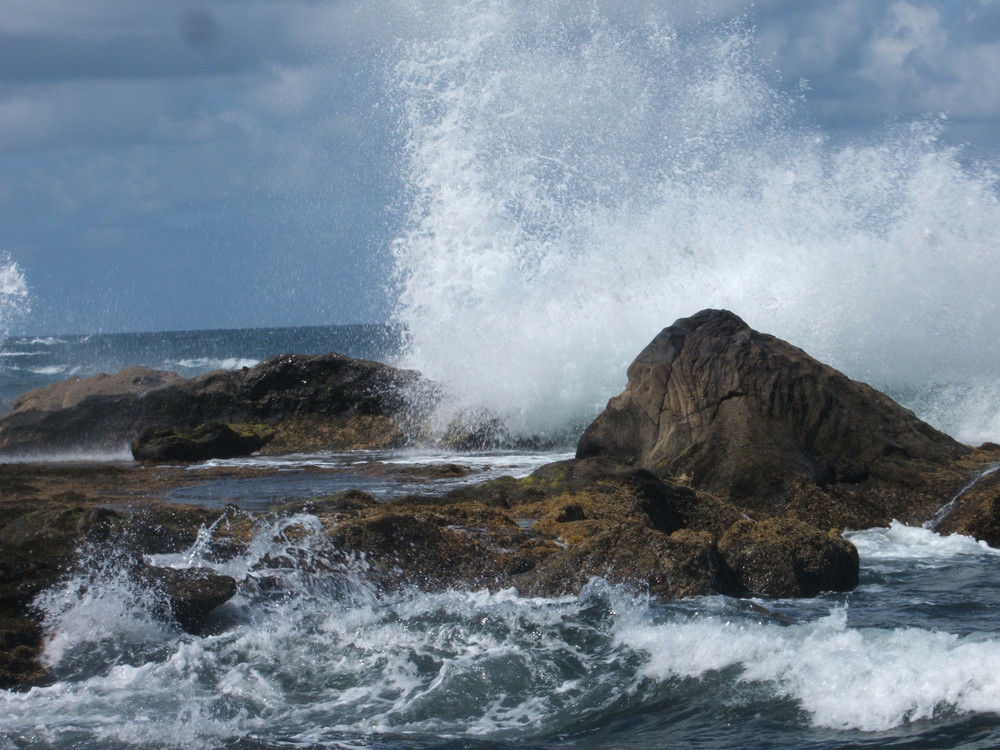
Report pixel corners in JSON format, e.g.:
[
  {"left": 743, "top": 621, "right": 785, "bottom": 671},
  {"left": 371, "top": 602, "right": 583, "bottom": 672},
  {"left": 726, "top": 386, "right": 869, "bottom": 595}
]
[{"left": 719, "top": 518, "right": 859, "bottom": 597}]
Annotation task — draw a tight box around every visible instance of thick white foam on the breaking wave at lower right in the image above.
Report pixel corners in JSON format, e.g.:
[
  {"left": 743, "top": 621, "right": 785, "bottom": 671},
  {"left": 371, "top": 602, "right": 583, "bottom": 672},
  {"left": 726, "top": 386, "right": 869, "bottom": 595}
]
[{"left": 618, "top": 610, "right": 1000, "bottom": 731}]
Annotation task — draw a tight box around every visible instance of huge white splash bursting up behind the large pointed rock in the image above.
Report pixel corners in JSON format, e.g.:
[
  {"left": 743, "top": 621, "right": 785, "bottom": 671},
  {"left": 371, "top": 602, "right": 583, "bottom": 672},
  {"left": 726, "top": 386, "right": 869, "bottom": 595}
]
[{"left": 393, "top": 0, "right": 1000, "bottom": 440}]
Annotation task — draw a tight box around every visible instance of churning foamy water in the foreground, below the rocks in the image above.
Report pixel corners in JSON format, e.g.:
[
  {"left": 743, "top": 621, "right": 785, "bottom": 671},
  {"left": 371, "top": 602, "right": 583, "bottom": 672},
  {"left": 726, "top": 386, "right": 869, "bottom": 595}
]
[{"left": 0, "top": 514, "right": 1000, "bottom": 748}]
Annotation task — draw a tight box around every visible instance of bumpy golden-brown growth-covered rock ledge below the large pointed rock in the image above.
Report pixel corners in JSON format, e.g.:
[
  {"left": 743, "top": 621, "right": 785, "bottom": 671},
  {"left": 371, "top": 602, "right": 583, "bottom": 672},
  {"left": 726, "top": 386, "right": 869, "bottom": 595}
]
[{"left": 332, "top": 458, "right": 858, "bottom": 599}]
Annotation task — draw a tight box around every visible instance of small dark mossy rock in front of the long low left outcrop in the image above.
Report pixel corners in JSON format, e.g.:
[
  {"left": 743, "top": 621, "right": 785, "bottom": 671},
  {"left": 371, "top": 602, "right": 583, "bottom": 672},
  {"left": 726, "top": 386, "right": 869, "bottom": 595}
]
[{"left": 131, "top": 422, "right": 275, "bottom": 463}]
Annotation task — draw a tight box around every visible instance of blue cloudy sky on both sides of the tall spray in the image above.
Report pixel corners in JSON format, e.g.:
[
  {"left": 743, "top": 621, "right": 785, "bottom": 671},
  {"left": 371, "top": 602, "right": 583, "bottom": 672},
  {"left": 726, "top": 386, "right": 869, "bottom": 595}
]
[{"left": 0, "top": 0, "right": 1000, "bottom": 334}]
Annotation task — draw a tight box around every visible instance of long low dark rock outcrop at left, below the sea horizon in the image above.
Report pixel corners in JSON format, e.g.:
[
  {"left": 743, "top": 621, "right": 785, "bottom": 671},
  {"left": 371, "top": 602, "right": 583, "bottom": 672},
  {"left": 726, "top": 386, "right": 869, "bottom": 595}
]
[{"left": 0, "top": 354, "right": 435, "bottom": 460}]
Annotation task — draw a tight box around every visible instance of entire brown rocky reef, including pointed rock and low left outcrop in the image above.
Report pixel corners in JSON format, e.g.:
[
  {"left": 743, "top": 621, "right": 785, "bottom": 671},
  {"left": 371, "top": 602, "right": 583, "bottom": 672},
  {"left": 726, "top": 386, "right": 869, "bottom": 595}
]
[{"left": 0, "top": 310, "right": 1000, "bottom": 686}]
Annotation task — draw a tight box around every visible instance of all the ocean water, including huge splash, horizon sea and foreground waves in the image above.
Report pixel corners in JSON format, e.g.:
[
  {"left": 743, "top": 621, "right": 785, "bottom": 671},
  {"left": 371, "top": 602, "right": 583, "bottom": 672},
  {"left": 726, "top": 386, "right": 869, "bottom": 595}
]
[{"left": 0, "top": 0, "right": 1000, "bottom": 750}]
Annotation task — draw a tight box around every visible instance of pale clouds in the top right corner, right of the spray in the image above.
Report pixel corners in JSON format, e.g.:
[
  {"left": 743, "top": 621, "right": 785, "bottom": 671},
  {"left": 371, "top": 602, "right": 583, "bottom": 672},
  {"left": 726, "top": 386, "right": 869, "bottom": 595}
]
[{"left": 757, "top": 0, "right": 1000, "bottom": 135}]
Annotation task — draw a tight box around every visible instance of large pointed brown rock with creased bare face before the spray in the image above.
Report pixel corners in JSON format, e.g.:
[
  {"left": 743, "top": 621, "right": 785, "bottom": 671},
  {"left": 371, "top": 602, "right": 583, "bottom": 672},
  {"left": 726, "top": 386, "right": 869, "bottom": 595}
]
[{"left": 577, "top": 310, "right": 970, "bottom": 523}]
